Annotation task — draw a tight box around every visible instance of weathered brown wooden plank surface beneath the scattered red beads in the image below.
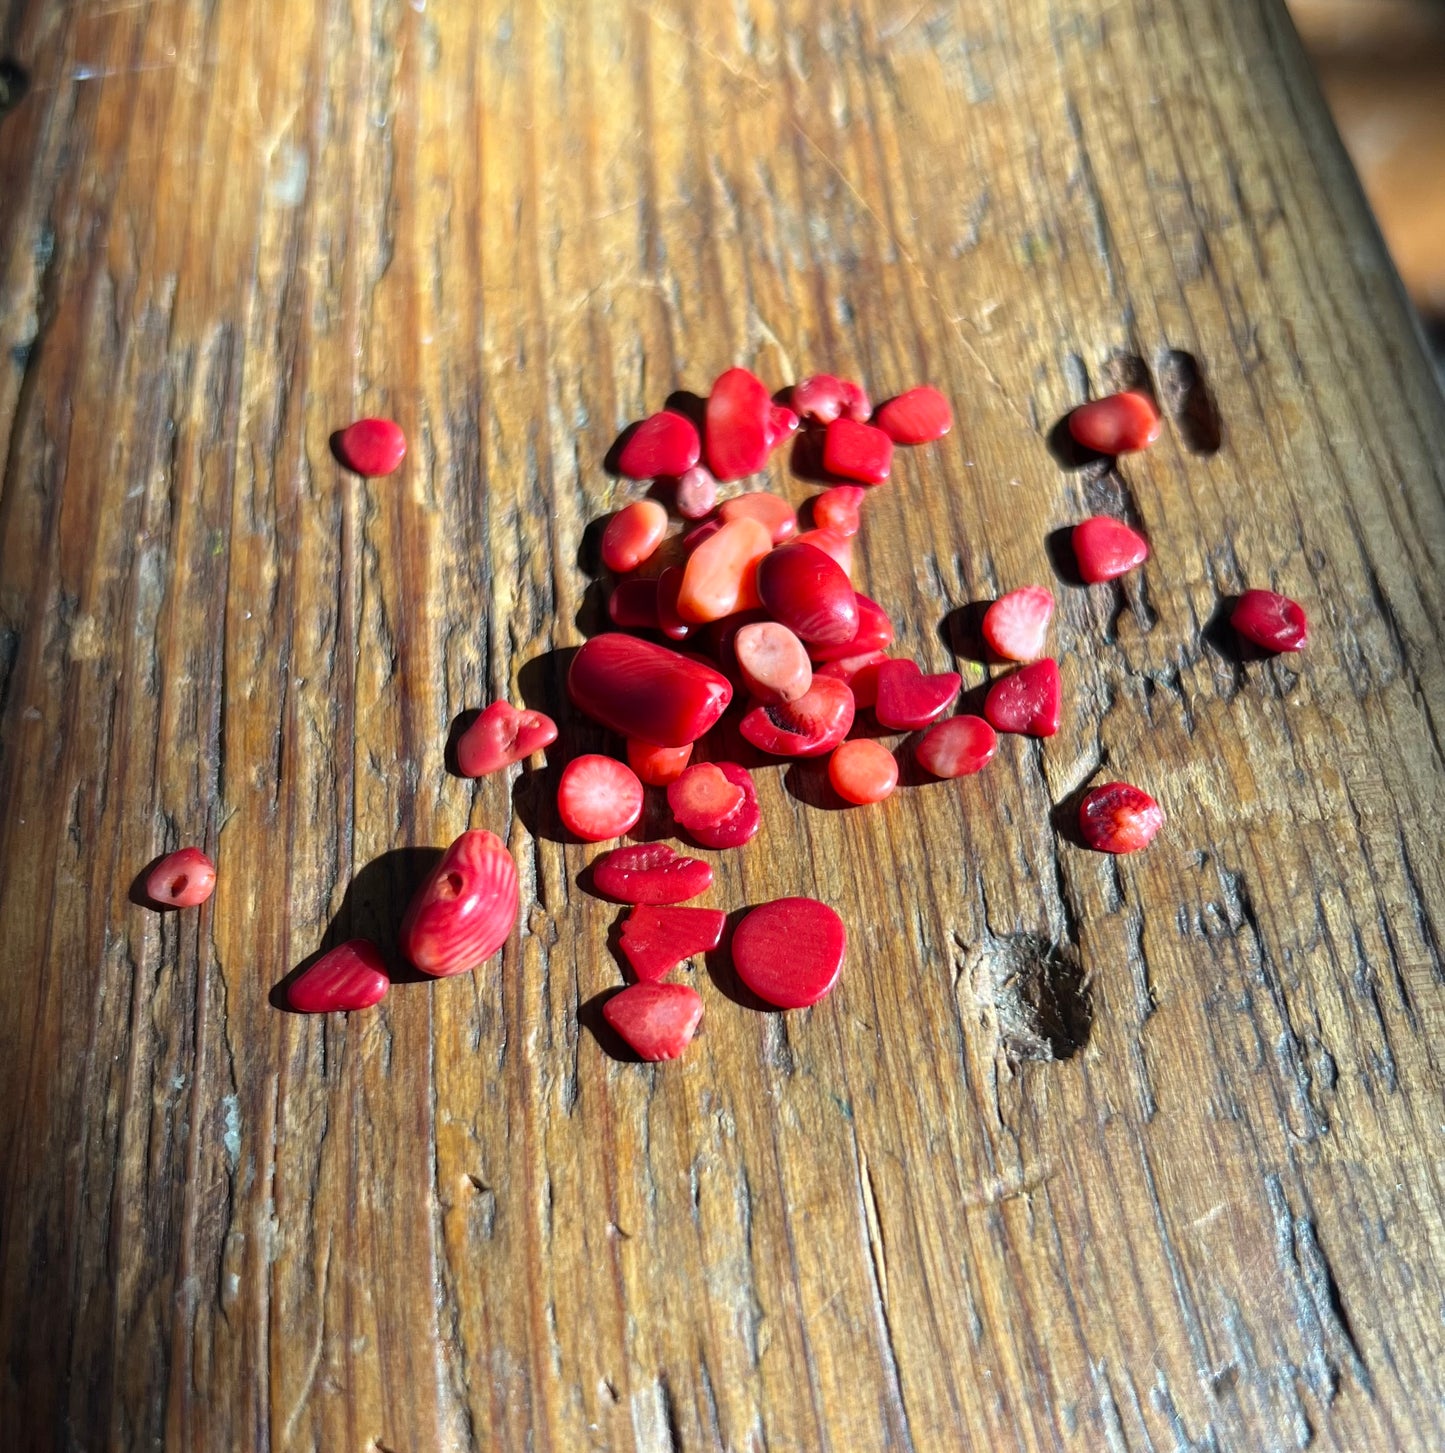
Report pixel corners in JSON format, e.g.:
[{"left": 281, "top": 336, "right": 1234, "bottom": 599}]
[{"left": 0, "top": 0, "right": 1445, "bottom": 1453}]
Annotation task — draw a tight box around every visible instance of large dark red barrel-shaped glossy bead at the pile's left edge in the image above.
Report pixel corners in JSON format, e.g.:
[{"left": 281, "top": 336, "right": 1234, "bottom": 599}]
[{"left": 567, "top": 632, "right": 733, "bottom": 747}]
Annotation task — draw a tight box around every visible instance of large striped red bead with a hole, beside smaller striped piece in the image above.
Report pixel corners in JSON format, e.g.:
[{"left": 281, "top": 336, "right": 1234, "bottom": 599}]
[{"left": 401, "top": 831, "right": 519, "bottom": 978}]
